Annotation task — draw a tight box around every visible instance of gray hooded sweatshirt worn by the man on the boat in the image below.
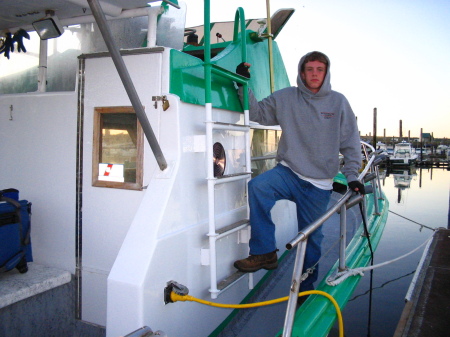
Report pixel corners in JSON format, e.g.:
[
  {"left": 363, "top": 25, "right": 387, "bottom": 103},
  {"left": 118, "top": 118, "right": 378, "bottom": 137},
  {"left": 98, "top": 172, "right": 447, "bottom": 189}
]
[{"left": 239, "top": 54, "right": 361, "bottom": 182}]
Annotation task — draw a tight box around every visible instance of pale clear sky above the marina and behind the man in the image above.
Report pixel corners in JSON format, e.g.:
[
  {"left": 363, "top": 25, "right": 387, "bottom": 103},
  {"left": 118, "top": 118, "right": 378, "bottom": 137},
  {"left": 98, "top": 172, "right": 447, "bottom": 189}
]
[{"left": 185, "top": 0, "right": 450, "bottom": 138}]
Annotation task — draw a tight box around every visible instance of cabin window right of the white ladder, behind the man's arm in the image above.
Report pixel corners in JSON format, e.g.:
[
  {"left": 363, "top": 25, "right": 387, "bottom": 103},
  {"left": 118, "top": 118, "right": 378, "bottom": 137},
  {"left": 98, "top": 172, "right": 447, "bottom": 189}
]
[{"left": 251, "top": 128, "right": 281, "bottom": 178}]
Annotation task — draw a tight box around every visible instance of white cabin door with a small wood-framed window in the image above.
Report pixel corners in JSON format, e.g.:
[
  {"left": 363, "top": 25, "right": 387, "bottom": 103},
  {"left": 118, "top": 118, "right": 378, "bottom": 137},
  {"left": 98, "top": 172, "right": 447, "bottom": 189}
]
[{"left": 77, "top": 48, "right": 163, "bottom": 326}]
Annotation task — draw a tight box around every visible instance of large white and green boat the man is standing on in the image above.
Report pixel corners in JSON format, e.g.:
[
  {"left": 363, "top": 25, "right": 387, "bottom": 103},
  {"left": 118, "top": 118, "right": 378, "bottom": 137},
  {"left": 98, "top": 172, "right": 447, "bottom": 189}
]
[{"left": 0, "top": 0, "right": 388, "bottom": 337}]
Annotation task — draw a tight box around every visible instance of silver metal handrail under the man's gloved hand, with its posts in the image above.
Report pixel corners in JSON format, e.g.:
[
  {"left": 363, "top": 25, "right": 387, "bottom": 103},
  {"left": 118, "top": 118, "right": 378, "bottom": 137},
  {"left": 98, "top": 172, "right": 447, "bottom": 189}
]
[{"left": 283, "top": 141, "right": 379, "bottom": 337}]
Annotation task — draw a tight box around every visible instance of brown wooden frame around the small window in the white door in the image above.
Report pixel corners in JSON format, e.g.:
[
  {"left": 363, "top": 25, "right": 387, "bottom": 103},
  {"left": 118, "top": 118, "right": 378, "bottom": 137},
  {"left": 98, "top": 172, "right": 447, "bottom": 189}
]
[{"left": 92, "top": 106, "right": 145, "bottom": 191}]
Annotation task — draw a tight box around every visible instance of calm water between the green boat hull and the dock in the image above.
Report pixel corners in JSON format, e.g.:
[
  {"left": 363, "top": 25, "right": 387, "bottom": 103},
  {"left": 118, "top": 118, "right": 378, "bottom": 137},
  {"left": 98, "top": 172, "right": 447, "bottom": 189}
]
[{"left": 330, "top": 168, "right": 450, "bottom": 337}]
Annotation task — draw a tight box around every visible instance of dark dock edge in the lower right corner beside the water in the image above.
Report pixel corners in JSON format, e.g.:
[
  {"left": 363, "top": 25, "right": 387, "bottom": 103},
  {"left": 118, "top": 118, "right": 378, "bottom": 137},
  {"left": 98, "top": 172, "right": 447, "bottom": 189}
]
[{"left": 394, "top": 228, "right": 450, "bottom": 337}]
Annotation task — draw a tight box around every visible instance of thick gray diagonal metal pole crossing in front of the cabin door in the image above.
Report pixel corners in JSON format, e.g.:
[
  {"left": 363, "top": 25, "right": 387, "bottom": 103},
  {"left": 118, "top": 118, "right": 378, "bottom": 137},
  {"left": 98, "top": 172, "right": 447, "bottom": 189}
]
[{"left": 87, "top": 0, "right": 167, "bottom": 170}]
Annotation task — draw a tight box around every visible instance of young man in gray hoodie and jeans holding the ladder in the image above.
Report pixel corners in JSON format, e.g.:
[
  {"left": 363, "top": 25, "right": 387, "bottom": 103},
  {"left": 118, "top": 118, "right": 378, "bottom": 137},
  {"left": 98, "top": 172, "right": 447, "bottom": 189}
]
[{"left": 234, "top": 51, "right": 365, "bottom": 291}]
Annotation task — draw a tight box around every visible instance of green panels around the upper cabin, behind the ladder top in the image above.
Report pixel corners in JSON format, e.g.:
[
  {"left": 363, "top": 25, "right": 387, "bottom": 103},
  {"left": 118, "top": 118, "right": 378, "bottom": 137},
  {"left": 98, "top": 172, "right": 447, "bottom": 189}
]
[{"left": 169, "top": 31, "right": 290, "bottom": 111}]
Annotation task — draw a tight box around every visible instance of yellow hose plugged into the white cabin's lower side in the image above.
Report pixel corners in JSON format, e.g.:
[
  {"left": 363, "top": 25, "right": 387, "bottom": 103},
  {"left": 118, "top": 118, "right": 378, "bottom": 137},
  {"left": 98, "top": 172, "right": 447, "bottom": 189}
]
[{"left": 170, "top": 290, "right": 344, "bottom": 337}]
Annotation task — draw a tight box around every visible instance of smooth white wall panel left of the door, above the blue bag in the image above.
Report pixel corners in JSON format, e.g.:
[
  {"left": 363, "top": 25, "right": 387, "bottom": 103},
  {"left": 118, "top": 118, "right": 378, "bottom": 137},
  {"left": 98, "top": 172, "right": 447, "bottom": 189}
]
[{"left": 0, "top": 92, "right": 77, "bottom": 273}]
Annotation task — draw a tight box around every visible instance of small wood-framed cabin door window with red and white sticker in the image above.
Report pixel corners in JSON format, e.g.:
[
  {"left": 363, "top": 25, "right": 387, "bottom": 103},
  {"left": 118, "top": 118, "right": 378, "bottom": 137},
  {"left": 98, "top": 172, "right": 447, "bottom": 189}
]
[{"left": 92, "top": 107, "right": 144, "bottom": 190}]
